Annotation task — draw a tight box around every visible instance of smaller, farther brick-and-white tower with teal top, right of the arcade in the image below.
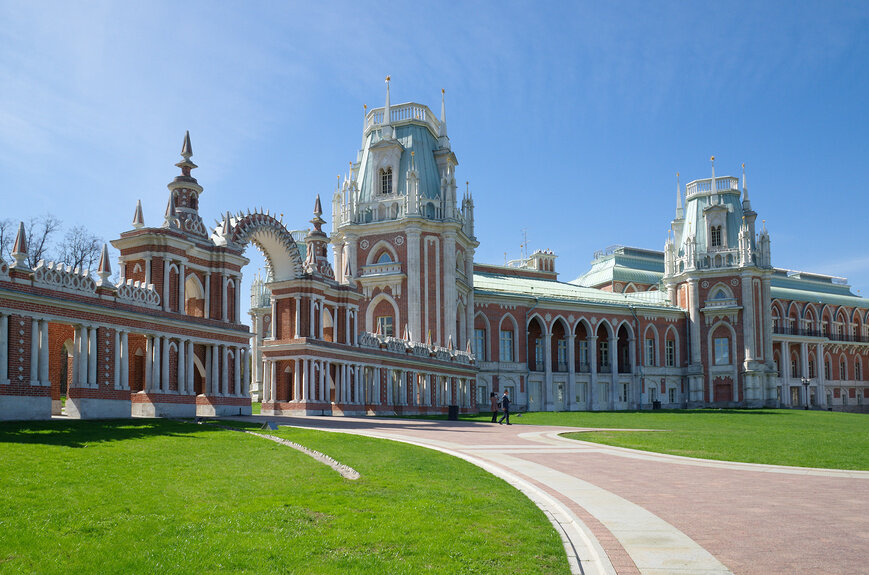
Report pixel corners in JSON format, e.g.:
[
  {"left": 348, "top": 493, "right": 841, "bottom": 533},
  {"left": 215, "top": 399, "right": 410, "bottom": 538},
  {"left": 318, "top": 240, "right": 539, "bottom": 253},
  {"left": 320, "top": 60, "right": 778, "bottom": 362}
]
[{"left": 664, "top": 160, "right": 775, "bottom": 406}]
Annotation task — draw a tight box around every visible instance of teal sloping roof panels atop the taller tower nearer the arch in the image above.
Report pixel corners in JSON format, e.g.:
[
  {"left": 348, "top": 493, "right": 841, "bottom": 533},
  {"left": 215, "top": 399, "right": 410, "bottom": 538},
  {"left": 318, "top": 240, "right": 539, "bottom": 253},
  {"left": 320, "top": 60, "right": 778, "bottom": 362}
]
[{"left": 359, "top": 123, "right": 441, "bottom": 202}]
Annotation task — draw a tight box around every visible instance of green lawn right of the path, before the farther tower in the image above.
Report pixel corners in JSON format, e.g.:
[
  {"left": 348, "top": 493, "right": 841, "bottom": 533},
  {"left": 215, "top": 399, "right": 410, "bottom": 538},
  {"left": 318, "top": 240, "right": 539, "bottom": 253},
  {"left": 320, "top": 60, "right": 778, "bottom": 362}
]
[{"left": 463, "top": 409, "right": 869, "bottom": 470}]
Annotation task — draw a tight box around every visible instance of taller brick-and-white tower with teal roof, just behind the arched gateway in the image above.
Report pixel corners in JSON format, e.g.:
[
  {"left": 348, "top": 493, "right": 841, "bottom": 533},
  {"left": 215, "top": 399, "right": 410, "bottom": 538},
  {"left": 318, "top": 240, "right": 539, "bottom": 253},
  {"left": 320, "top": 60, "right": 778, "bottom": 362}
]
[{"left": 331, "top": 76, "right": 479, "bottom": 347}]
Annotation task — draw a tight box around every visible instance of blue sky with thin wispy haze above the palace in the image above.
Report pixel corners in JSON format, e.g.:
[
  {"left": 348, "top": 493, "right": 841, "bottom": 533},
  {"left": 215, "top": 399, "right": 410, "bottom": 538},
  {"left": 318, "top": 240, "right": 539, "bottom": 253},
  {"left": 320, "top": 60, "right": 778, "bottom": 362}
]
[{"left": 0, "top": 0, "right": 869, "bottom": 324}]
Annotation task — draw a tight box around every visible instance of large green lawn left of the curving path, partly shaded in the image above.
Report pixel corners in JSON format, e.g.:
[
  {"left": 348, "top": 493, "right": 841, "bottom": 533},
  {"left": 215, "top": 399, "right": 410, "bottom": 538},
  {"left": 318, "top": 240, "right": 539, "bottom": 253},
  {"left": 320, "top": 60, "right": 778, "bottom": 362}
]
[{"left": 0, "top": 420, "right": 569, "bottom": 575}]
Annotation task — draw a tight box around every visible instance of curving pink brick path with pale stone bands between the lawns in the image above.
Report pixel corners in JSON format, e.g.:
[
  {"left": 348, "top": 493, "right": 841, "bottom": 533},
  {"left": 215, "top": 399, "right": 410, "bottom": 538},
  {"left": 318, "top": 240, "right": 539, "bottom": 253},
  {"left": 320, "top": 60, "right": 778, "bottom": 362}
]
[{"left": 236, "top": 417, "right": 869, "bottom": 575}]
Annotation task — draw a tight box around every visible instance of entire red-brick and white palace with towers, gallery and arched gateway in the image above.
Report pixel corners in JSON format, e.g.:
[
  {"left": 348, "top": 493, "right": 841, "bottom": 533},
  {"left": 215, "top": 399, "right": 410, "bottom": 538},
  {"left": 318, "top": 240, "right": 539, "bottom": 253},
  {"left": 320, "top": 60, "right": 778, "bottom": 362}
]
[{"left": 0, "top": 82, "right": 869, "bottom": 419}]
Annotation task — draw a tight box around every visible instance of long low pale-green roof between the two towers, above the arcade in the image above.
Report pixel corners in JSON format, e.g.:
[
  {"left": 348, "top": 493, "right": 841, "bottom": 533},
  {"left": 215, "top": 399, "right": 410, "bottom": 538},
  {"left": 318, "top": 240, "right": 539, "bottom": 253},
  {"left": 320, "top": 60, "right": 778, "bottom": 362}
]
[{"left": 474, "top": 272, "right": 681, "bottom": 311}]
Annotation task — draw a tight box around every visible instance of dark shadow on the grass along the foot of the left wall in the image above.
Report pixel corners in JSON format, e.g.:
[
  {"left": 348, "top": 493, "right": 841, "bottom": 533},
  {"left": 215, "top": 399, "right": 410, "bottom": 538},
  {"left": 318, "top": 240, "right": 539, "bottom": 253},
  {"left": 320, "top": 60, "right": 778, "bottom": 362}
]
[{"left": 0, "top": 419, "right": 221, "bottom": 448}]
